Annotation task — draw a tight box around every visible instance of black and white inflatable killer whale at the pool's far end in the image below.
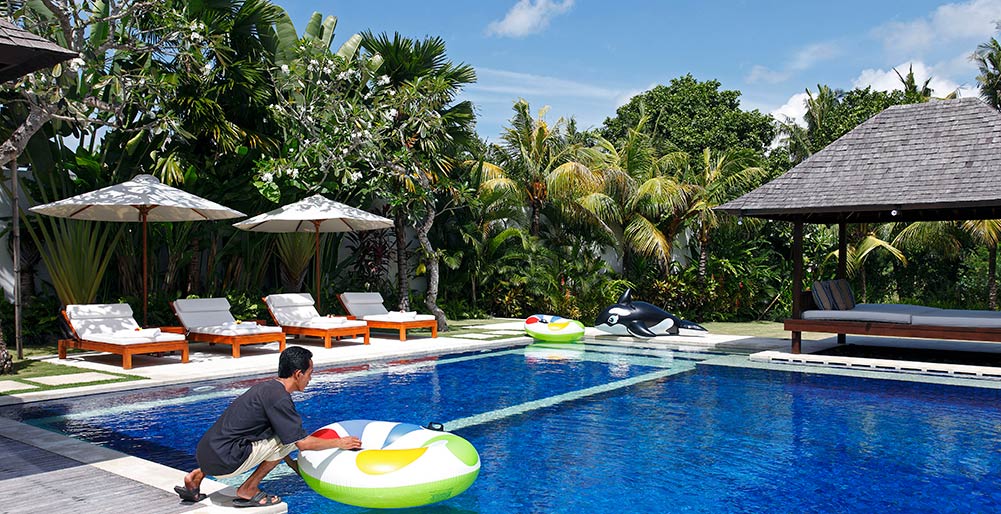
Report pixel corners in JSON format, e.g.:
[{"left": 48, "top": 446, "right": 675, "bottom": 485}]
[{"left": 595, "top": 290, "right": 709, "bottom": 338}]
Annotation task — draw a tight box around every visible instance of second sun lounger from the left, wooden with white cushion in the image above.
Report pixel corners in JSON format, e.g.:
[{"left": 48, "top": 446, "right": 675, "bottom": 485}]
[{"left": 170, "top": 298, "right": 285, "bottom": 359}]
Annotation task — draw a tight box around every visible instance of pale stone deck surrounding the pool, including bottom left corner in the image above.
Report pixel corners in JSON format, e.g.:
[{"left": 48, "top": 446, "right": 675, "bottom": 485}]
[{"left": 0, "top": 321, "right": 1001, "bottom": 514}]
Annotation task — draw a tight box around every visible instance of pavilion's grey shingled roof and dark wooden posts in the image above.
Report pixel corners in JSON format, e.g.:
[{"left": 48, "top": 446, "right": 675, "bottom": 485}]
[{"left": 718, "top": 98, "right": 1001, "bottom": 353}]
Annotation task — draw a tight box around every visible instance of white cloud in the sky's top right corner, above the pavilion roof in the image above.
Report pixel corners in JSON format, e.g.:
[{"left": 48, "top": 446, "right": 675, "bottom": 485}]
[{"left": 873, "top": 0, "right": 1001, "bottom": 54}]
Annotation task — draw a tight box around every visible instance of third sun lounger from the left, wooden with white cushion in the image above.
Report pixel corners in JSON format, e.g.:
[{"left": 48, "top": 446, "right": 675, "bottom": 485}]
[{"left": 263, "top": 293, "right": 368, "bottom": 348}]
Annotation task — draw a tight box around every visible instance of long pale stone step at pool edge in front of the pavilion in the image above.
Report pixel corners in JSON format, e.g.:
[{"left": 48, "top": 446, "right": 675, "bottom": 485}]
[{"left": 749, "top": 350, "right": 1001, "bottom": 380}]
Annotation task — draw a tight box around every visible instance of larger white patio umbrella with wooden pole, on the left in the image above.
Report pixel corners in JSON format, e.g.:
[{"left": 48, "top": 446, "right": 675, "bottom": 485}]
[{"left": 28, "top": 174, "right": 245, "bottom": 325}]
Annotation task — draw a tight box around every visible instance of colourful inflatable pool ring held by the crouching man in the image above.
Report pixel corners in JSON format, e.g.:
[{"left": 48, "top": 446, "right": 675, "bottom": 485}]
[{"left": 299, "top": 420, "right": 479, "bottom": 509}]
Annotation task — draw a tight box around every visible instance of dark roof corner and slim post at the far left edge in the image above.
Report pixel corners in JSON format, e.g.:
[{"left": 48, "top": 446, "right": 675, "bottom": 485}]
[{"left": 0, "top": 19, "right": 80, "bottom": 356}]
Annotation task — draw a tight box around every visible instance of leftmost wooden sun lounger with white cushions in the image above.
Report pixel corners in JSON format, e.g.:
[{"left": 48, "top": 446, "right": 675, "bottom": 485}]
[{"left": 59, "top": 304, "right": 188, "bottom": 370}]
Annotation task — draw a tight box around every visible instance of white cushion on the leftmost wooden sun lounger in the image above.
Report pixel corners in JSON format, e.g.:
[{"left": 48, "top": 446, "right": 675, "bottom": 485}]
[{"left": 66, "top": 304, "right": 184, "bottom": 345}]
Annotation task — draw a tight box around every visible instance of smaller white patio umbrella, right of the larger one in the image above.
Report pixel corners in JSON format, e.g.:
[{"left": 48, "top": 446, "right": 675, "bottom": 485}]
[{"left": 233, "top": 194, "right": 392, "bottom": 308}]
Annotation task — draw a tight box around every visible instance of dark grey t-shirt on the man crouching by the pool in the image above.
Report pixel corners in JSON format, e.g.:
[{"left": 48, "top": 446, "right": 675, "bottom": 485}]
[{"left": 195, "top": 380, "right": 306, "bottom": 475}]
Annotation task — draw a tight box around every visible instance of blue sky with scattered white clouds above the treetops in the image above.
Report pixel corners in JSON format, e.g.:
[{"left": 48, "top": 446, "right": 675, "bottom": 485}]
[{"left": 276, "top": 0, "right": 1001, "bottom": 140}]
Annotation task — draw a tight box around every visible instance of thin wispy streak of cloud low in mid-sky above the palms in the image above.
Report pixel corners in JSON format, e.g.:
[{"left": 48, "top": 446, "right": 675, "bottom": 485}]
[{"left": 465, "top": 68, "right": 623, "bottom": 100}]
